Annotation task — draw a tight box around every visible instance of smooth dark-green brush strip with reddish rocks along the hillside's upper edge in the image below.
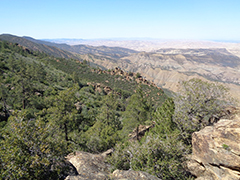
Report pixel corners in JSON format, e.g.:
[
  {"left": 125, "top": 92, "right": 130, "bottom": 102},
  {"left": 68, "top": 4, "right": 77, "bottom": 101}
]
[{"left": 0, "top": 38, "right": 167, "bottom": 105}]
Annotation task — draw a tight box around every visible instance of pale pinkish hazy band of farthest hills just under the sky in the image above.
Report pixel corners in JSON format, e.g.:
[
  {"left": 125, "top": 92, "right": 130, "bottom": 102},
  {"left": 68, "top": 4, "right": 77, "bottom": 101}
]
[{"left": 38, "top": 38, "right": 240, "bottom": 52}]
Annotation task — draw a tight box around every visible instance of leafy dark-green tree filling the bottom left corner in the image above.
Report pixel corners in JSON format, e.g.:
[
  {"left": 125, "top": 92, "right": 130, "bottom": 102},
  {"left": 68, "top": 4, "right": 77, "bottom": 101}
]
[{"left": 0, "top": 110, "right": 67, "bottom": 180}]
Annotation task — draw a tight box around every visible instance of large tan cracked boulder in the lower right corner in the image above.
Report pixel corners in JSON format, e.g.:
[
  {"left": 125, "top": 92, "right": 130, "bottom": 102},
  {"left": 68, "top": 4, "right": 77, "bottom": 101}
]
[{"left": 188, "top": 116, "right": 240, "bottom": 180}]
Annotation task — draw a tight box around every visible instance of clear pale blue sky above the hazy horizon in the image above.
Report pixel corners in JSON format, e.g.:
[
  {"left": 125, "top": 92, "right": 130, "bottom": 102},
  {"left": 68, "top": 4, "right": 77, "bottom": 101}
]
[{"left": 0, "top": 0, "right": 240, "bottom": 40}]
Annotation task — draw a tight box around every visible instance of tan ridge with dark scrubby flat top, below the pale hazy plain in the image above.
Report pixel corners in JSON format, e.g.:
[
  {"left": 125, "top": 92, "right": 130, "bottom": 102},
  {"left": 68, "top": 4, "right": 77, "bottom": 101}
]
[{"left": 123, "top": 49, "right": 240, "bottom": 85}]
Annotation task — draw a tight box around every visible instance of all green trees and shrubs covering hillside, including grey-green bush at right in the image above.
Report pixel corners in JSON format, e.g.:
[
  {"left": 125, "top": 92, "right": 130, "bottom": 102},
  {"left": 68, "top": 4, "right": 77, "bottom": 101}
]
[{"left": 0, "top": 41, "right": 233, "bottom": 179}]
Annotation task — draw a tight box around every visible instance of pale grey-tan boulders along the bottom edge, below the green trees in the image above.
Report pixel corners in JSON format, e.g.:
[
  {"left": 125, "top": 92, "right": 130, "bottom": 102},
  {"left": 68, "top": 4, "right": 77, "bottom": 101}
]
[{"left": 66, "top": 150, "right": 159, "bottom": 180}]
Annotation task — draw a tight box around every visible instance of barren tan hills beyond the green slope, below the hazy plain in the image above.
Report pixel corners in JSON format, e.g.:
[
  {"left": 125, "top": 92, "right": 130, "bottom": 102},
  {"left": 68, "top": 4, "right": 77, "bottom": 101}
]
[{"left": 81, "top": 49, "right": 240, "bottom": 102}]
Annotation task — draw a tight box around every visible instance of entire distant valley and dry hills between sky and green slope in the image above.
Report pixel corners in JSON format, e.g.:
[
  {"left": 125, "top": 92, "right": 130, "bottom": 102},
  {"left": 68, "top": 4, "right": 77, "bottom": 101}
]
[{"left": 0, "top": 35, "right": 240, "bottom": 101}]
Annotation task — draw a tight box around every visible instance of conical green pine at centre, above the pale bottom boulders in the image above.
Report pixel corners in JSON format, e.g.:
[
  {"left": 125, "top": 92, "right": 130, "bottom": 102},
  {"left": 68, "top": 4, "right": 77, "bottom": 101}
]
[{"left": 86, "top": 93, "right": 122, "bottom": 152}]
